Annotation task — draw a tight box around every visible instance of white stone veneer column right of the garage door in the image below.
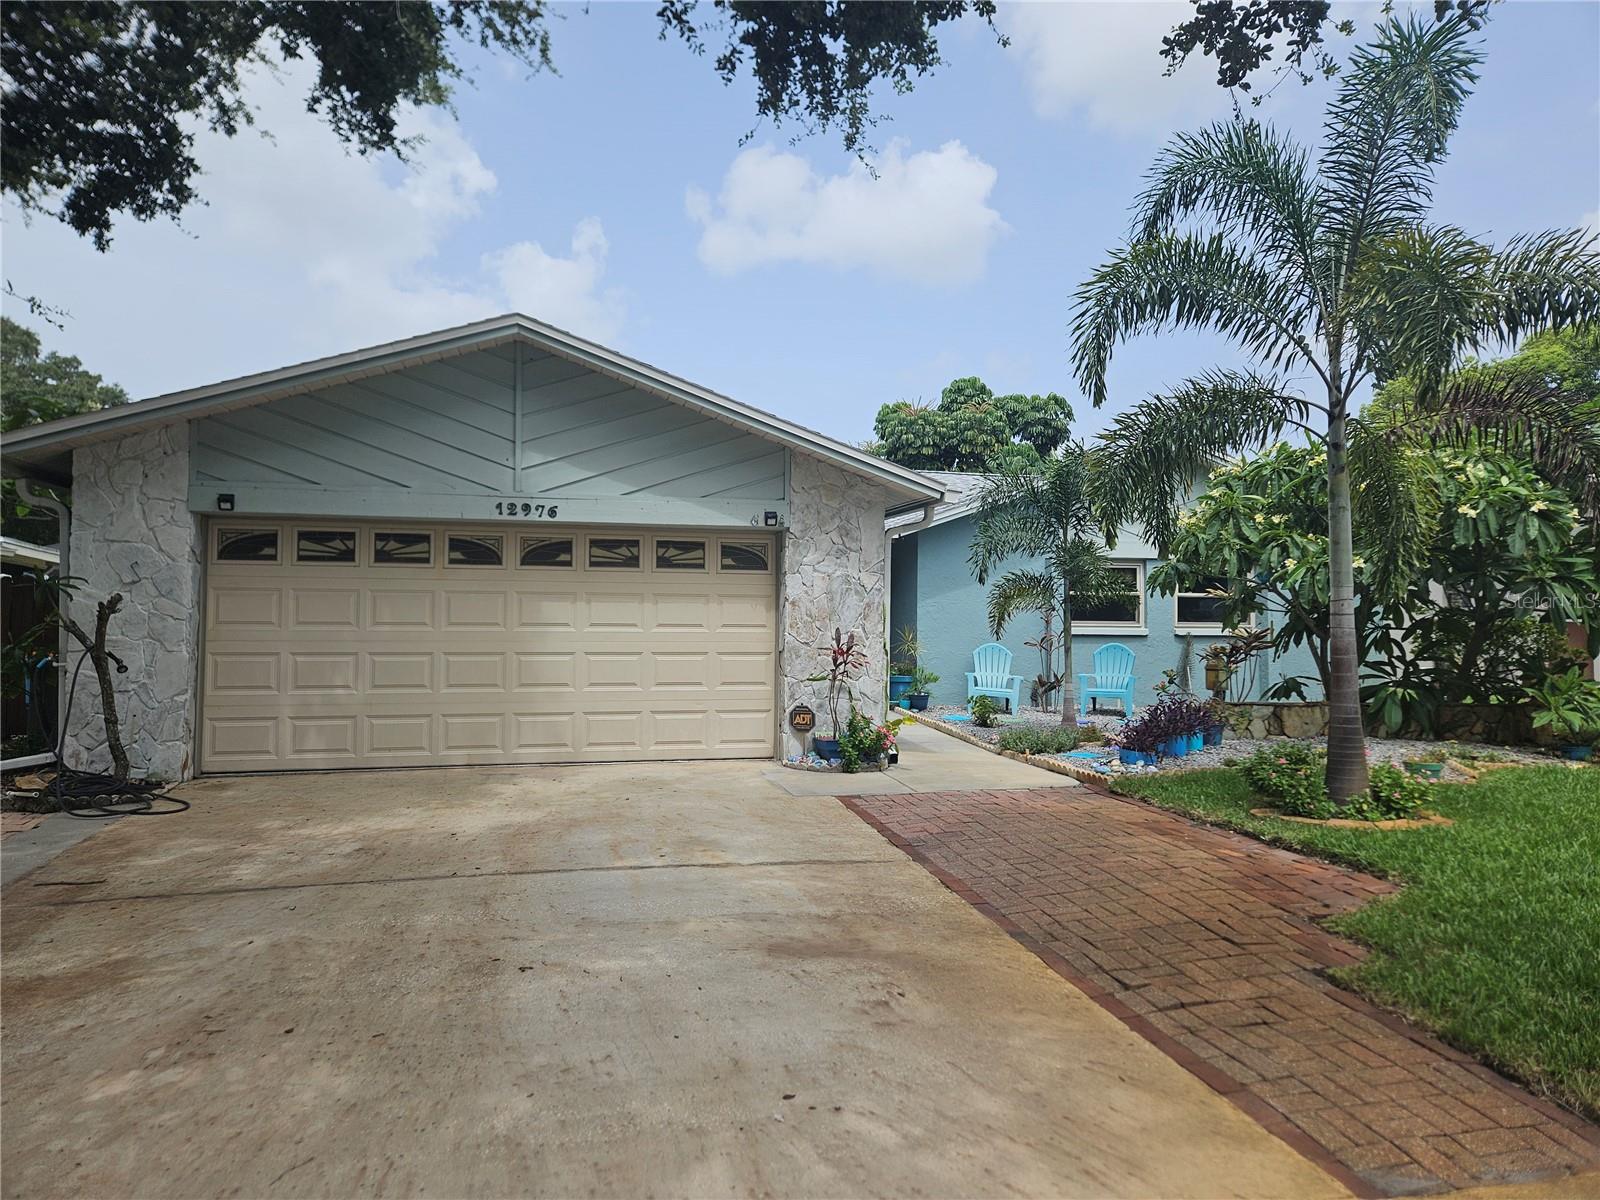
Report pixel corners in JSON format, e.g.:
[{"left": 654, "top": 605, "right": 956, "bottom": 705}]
[{"left": 778, "top": 453, "right": 890, "bottom": 755}]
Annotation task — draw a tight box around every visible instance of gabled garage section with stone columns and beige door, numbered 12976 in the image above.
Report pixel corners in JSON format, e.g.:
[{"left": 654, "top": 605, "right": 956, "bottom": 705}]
[{"left": 3, "top": 315, "right": 941, "bottom": 778}]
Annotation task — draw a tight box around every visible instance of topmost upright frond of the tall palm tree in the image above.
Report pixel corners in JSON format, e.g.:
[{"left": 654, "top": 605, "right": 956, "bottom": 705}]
[{"left": 1318, "top": 18, "right": 1482, "bottom": 288}]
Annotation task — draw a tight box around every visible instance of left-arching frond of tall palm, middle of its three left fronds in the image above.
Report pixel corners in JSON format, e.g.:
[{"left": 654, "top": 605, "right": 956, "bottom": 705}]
[{"left": 1072, "top": 234, "right": 1322, "bottom": 406}]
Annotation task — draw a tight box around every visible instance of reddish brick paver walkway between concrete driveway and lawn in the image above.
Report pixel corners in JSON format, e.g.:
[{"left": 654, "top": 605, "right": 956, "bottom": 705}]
[{"left": 843, "top": 787, "right": 1600, "bottom": 1195}]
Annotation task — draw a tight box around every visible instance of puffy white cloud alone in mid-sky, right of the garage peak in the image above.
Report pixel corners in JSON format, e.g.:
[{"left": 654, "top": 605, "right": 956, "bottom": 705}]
[{"left": 686, "top": 141, "right": 1006, "bottom": 285}]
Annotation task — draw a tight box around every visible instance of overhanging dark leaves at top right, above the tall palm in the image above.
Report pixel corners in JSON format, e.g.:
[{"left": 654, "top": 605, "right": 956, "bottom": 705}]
[{"left": 1162, "top": 0, "right": 1488, "bottom": 91}]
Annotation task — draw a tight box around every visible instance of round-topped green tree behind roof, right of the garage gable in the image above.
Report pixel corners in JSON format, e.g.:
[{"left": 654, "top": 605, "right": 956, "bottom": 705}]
[{"left": 872, "top": 376, "right": 1072, "bottom": 470}]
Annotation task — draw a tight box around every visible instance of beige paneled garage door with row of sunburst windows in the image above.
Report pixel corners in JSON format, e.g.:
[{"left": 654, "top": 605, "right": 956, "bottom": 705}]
[{"left": 200, "top": 518, "right": 778, "bottom": 771}]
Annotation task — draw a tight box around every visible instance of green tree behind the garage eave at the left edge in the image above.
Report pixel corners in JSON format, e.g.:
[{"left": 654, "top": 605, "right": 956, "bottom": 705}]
[{"left": 0, "top": 317, "right": 128, "bottom": 544}]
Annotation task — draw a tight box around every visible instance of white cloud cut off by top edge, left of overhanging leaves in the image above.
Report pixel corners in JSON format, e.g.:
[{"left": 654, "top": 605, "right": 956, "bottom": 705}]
[{"left": 1000, "top": 0, "right": 1227, "bottom": 136}]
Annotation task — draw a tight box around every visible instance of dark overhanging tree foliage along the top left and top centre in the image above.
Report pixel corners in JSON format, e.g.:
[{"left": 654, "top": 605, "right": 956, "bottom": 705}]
[{"left": 0, "top": 0, "right": 1005, "bottom": 251}]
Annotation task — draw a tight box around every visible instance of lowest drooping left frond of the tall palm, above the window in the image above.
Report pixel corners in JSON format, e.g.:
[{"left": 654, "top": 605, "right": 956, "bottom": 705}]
[{"left": 1094, "top": 371, "right": 1310, "bottom": 550}]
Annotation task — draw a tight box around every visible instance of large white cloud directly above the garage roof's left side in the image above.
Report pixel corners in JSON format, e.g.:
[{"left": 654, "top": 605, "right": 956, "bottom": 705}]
[{"left": 5, "top": 64, "right": 626, "bottom": 395}]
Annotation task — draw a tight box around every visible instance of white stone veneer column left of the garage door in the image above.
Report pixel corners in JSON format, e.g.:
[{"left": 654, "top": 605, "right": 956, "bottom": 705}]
[{"left": 61, "top": 424, "right": 203, "bottom": 779}]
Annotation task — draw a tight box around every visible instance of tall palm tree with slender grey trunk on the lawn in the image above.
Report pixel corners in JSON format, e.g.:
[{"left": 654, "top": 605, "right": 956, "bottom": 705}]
[{"left": 1072, "top": 19, "right": 1600, "bottom": 802}]
